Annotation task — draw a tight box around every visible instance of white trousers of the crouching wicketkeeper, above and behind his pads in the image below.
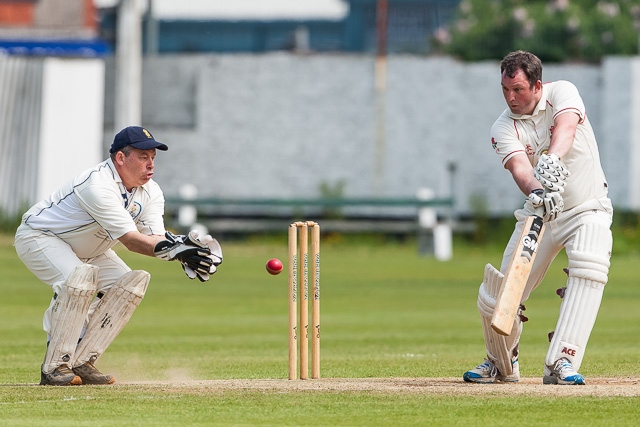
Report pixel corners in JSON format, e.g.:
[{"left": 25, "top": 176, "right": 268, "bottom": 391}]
[{"left": 14, "top": 224, "right": 131, "bottom": 335}]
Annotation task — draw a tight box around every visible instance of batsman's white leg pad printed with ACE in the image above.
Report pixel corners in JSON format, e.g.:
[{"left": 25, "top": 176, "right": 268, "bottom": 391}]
[{"left": 545, "top": 224, "right": 613, "bottom": 371}]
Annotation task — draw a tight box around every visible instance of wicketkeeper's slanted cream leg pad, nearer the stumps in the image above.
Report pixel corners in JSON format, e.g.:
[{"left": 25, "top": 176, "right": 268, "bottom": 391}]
[{"left": 72, "top": 270, "right": 151, "bottom": 367}]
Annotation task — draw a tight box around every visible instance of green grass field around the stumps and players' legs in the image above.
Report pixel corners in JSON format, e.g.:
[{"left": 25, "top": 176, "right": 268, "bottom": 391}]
[{"left": 0, "top": 233, "right": 640, "bottom": 426}]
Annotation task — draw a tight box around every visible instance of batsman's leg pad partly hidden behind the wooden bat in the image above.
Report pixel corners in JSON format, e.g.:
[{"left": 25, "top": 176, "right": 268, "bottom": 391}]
[{"left": 478, "top": 264, "right": 522, "bottom": 375}]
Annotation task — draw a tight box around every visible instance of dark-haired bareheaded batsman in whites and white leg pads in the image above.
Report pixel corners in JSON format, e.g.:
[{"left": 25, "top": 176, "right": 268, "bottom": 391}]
[{"left": 463, "top": 51, "right": 613, "bottom": 385}]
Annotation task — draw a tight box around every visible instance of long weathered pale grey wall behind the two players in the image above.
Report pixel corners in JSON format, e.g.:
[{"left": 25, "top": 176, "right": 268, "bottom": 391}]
[{"left": 104, "top": 53, "right": 640, "bottom": 215}]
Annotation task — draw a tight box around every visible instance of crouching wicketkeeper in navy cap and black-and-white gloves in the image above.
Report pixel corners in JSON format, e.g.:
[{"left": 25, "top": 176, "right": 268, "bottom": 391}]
[{"left": 14, "top": 126, "right": 222, "bottom": 386}]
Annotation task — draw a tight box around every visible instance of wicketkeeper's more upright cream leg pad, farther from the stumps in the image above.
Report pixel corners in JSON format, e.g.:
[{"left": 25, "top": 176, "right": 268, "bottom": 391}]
[{"left": 42, "top": 264, "right": 99, "bottom": 373}]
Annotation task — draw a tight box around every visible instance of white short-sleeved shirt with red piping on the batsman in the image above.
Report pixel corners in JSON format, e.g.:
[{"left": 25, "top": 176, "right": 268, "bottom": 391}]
[{"left": 491, "top": 80, "right": 607, "bottom": 210}]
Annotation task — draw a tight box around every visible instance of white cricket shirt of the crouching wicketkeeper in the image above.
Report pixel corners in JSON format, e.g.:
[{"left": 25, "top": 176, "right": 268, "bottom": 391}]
[{"left": 22, "top": 159, "right": 165, "bottom": 259}]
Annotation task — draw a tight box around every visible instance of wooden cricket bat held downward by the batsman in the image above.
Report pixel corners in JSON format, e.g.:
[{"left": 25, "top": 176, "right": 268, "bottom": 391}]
[{"left": 491, "top": 215, "right": 544, "bottom": 336}]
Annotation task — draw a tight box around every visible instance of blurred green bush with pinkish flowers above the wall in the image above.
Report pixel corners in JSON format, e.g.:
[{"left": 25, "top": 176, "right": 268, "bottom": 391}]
[{"left": 433, "top": 0, "right": 640, "bottom": 62}]
